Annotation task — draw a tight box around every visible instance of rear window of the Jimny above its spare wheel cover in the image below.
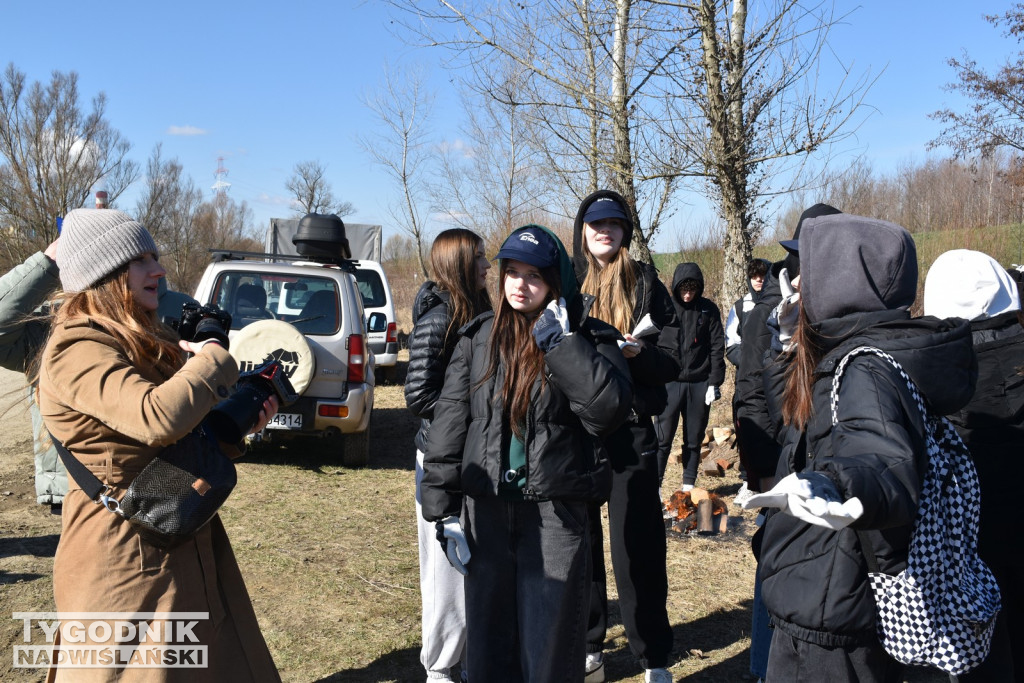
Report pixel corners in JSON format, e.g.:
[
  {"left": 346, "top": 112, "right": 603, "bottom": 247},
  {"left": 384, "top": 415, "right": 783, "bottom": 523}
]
[{"left": 213, "top": 271, "right": 341, "bottom": 335}]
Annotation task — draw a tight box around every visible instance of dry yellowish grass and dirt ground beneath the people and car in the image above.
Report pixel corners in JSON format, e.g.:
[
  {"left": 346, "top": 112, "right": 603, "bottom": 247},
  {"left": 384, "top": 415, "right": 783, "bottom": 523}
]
[{"left": 0, "top": 360, "right": 943, "bottom": 683}]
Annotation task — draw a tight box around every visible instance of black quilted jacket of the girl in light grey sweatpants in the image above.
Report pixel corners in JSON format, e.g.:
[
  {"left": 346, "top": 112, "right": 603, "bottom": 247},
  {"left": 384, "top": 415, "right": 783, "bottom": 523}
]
[{"left": 406, "top": 280, "right": 458, "bottom": 453}]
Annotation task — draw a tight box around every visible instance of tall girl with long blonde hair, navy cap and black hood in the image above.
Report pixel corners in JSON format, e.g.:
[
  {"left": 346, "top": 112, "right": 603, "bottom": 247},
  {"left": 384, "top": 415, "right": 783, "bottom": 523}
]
[{"left": 572, "top": 189, "right": 679, "bottom": 683}]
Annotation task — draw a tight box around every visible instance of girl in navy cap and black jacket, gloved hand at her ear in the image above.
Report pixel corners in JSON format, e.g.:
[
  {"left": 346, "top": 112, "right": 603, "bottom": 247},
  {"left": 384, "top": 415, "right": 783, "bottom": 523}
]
[{"left": 422, "top": 225, "right": 632, "bottom": 682}]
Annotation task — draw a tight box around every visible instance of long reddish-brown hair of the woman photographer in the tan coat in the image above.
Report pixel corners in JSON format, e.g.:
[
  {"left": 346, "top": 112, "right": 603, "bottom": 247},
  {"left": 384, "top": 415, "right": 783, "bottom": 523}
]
[{"left": 31, "top": 265, "right": 184, "bottom": 380}]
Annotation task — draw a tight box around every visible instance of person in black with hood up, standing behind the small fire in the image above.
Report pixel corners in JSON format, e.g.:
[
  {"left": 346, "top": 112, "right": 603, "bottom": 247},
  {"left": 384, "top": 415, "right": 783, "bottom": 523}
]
[{"left": 654, "top": 263, "right": 725, "bottom": 490}]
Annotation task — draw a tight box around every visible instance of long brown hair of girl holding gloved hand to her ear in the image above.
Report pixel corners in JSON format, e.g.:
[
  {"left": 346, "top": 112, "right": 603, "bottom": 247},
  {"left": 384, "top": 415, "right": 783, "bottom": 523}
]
[{"left": 484, "top": 258, "right": 562, "bottom": 438}]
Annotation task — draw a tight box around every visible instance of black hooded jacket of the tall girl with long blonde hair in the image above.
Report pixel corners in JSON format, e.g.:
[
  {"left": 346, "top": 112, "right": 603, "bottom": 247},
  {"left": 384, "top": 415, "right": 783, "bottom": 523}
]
[{"left": 572, "top": 189, "right": 679, "bottom": 416}]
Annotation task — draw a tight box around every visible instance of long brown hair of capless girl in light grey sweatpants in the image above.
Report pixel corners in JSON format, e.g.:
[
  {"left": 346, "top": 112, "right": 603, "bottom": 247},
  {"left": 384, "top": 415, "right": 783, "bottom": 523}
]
[{"left": 430, "top": 227, "right": 490, "bottom": 350}]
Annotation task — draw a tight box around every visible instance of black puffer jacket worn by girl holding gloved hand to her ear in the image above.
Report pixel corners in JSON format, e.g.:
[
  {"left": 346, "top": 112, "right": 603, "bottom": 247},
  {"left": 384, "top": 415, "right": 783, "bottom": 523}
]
[{"left": 421, "top": 312, "right": 632, "bottom": 521}]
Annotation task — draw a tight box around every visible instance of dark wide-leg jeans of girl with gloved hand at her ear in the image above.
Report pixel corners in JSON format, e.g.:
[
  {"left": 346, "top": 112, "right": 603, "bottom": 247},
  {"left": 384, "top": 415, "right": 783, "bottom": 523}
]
[{"left": 465, "top": 498, "right": 591, "bottom": 683}]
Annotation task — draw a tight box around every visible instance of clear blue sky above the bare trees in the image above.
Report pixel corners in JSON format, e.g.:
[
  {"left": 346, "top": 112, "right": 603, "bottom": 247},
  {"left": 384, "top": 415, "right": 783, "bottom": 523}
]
[{"left": 6, "top": 0, "right": 1018, "bottom": 249}]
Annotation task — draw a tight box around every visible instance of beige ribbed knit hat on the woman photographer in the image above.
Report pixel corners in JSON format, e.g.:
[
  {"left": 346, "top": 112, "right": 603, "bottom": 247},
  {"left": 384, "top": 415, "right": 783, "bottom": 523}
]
[{"left": 57, "top": 209, "right": 160, "bottom": 292}]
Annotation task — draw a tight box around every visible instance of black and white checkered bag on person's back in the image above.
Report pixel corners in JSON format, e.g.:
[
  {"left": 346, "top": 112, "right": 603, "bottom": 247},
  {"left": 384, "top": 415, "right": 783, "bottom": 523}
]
[{"left": 831, "top": 346, "right": 1000, "bottom": 675}]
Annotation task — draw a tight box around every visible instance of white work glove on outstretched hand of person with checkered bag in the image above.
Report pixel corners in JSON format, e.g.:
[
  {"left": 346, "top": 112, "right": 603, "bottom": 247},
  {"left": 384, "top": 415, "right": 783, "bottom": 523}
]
[{"left": 743, "top": 472, "right": 864, "bottom": 530}]
